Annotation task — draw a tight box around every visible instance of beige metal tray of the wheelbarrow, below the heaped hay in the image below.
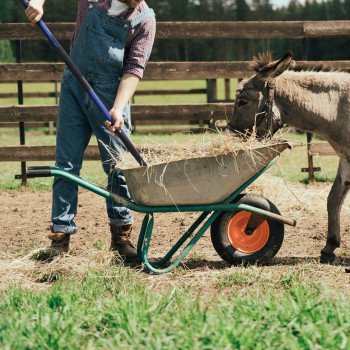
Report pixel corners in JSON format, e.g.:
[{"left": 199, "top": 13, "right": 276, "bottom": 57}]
[{"left": 123, "top": 142, "right": 289, "bottom": 206}]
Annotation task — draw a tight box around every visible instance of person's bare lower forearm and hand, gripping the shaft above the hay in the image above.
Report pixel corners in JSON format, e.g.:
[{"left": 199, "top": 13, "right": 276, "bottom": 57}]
[{"left": 105, "top": 73, "right": 140, "bottom": 133}]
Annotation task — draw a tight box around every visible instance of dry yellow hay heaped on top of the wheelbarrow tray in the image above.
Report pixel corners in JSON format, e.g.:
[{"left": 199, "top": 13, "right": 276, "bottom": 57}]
[{"left": 104, "top": 132, "right": 286, "bottom": 170}]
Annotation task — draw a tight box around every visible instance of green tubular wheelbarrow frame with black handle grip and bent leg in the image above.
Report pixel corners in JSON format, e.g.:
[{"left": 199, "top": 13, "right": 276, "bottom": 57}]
[{"left": 27, "top": 157, "right": 296, "bottom": 274}]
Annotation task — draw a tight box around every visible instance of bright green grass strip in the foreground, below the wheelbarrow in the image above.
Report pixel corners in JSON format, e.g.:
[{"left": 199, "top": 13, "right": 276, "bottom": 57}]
[{"left": 0, "top": 267, "right": 350, "bottom": 350}]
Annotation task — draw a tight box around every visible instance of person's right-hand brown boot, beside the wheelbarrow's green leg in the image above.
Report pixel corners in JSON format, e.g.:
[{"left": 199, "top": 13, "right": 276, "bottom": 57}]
[{"left": 110, "top": 225, "right": 141, "bottom": 262}]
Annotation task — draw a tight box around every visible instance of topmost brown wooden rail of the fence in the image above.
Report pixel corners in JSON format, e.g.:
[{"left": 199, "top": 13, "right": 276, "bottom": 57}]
[{"left": 0, "top": 21, "right": 350, "bottom": 40}]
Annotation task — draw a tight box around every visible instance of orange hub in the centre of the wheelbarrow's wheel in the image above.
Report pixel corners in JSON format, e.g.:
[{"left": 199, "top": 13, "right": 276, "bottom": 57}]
[{"left": 227, "top": 211, "right": 270, "bottom": 254}]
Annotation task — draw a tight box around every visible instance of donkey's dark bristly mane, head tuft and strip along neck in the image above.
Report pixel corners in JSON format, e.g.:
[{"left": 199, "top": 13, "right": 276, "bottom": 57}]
[{"left": 249, "top": 51, "right": 350, "bottom": 73}]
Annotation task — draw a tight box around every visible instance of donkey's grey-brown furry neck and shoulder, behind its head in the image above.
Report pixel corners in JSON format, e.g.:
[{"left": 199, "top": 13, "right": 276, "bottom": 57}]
[{"left": 275, "top": 71, "right": 350, "bottom": 139}]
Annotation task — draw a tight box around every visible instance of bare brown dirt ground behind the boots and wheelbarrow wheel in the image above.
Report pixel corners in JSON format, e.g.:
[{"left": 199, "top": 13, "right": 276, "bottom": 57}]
[{"left": 0, "top": 175, "right": 350, "bottom": 291}]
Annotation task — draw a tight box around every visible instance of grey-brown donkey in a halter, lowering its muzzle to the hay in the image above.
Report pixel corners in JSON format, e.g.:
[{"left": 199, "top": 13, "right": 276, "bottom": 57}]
[{"left": 228, "top": 51, "right": 350, "bottom": 263}]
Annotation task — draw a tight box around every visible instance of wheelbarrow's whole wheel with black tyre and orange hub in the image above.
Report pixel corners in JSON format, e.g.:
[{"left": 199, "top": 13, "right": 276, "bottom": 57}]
[{"left": 211, "top": 194, "right": 284, "bottom": 265}]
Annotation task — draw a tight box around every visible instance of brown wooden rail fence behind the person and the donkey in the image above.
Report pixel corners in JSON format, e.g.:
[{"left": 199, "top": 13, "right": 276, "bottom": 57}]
[{"left": 0, "top": 21, "right": 350, "bottom": 183}]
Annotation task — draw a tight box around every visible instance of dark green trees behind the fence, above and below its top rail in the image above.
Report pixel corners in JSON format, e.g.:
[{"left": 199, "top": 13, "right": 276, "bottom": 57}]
[{"left": 0, "top": 0, "right": 350, "bottom": 62}]
